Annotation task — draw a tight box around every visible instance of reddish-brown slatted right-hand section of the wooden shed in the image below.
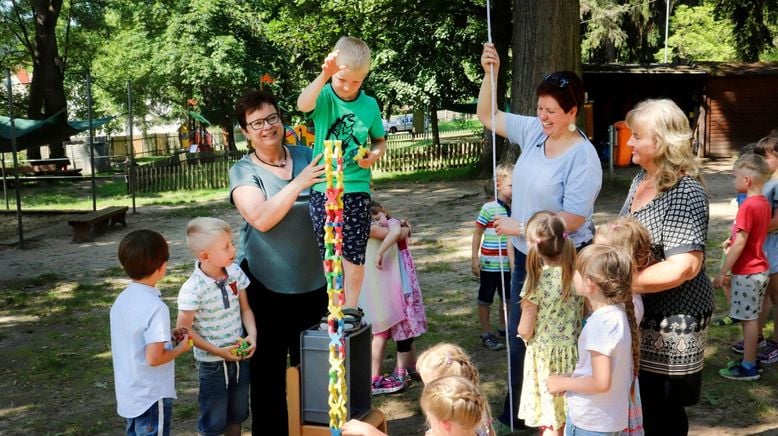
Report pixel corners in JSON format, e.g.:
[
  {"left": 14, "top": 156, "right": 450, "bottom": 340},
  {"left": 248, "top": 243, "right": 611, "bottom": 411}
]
[{"left": 697, "top": 62, "right": 778, "bottom": 157}]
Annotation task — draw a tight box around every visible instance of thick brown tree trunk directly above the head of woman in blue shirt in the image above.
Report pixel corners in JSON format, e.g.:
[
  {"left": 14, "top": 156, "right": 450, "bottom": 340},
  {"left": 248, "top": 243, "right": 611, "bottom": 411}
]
[{"left": 511, "top": 0, "right": 581, "bottom": 115}]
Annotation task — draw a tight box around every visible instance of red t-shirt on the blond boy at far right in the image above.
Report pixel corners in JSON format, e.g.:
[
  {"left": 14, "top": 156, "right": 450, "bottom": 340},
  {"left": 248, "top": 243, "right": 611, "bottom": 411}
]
[{"left": 732, "top": 195, "right": 772, "bottom": 275}]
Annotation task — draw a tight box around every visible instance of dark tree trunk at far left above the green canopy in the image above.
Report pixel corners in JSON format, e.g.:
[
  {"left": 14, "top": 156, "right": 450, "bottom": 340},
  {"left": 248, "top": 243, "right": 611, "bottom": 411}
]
[{"left": 27, "top": 0, "right": 67, "bottom": 159}]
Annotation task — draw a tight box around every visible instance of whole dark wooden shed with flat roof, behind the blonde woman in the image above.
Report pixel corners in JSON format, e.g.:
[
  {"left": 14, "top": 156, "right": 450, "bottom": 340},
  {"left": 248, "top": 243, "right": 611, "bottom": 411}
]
[{"left": 583, "top": 62, "right": 778, "bottom": 157}]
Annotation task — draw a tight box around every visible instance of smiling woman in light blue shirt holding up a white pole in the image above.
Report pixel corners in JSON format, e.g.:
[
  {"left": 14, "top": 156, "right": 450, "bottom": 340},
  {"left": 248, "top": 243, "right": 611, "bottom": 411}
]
[{"left": 478, "top": 43, "right": 602, "bottom": 427}]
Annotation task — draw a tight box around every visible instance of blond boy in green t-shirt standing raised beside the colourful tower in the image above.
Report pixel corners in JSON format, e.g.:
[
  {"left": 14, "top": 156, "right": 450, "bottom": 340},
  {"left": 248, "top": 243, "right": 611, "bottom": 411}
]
[{"left": 297, "top": 36, "right": 386, "bottom": 327}]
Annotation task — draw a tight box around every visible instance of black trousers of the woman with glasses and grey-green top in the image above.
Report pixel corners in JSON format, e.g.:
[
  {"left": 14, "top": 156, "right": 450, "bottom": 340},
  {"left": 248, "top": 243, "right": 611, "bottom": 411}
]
[{"left": 241, "top": 262, "right": 327, "bottom": 436}]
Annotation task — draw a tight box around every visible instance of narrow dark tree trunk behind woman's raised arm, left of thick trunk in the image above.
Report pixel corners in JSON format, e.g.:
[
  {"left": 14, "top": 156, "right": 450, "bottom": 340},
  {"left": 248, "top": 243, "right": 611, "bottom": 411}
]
[{"left": 478, "top": 0, "right": 515, "bottom": 181}]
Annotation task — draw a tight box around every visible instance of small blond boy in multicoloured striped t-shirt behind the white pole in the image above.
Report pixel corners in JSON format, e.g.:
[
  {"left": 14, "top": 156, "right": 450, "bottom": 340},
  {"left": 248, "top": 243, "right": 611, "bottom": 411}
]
[{"left": 471, "top": 164, "right": 513, "bottom": 351}]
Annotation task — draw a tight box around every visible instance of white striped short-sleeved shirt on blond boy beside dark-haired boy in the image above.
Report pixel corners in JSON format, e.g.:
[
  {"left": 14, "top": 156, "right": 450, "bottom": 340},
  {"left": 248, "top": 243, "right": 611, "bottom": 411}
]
[{"left": 178, "top": 262, "right": 249, "bottom": 362}]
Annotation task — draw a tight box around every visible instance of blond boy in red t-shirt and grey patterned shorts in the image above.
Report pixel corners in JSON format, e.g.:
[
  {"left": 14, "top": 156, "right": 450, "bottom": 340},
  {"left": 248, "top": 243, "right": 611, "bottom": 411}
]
[{"left": 714, "top": 154, "right": 772, "bottom": 380}]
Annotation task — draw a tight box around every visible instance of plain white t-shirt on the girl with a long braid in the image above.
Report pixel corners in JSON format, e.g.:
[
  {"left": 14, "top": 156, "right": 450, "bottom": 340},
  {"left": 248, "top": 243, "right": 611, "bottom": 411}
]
[{"left": 566, "top": 304, "right": 632, "bottom": 432}]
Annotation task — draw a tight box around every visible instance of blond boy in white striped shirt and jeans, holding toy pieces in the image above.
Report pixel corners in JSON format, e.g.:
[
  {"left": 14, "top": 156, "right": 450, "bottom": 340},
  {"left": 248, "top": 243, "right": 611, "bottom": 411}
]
[{"left": 176, "top": 217, "right": 257, "bottom": 436}]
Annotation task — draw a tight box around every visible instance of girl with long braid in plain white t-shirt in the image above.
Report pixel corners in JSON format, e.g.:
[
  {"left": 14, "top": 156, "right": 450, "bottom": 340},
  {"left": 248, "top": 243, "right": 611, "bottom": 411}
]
[{"left": 546, "top": 244, "right": 640, "bottom": 435}]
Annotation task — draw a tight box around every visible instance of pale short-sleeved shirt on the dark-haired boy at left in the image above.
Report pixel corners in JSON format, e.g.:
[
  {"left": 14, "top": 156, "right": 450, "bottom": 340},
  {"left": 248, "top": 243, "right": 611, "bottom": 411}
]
[{"left": 110, "top": 282, "right": 176, "bottom": 418}]
